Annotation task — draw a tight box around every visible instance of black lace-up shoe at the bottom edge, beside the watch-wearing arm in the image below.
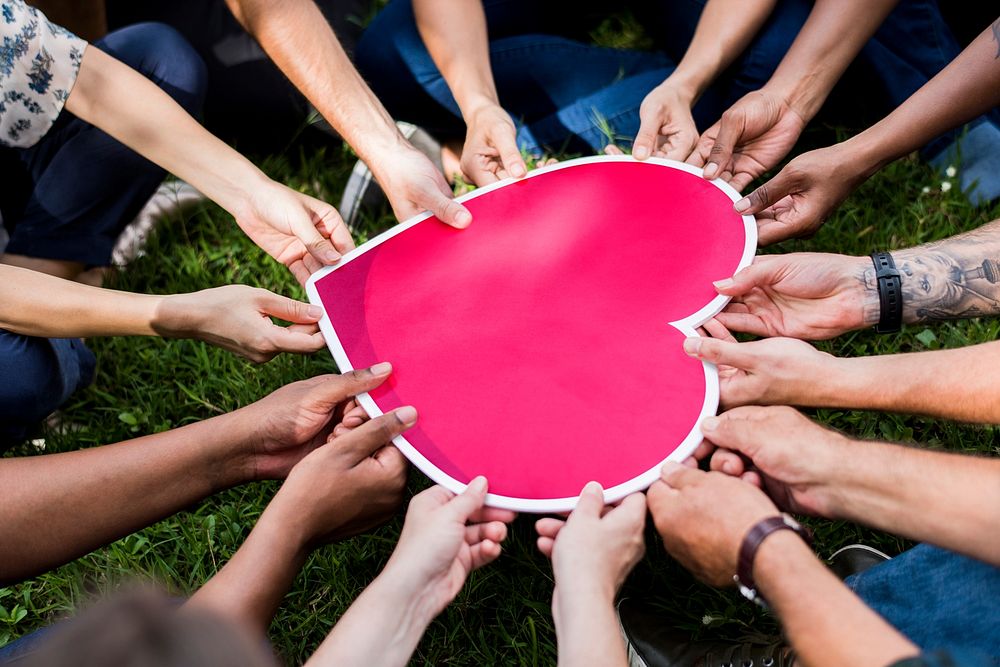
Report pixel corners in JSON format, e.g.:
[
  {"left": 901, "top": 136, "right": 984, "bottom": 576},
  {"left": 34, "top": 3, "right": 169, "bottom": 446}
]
[{"left": 618, "top": 600, "right": 795, "bottom": 667}]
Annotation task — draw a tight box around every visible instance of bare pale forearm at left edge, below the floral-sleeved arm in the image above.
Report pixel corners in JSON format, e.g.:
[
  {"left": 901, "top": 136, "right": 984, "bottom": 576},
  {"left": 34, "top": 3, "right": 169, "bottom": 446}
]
[{"left": 0, "top": 265, "right": 163, "bottom": 338}]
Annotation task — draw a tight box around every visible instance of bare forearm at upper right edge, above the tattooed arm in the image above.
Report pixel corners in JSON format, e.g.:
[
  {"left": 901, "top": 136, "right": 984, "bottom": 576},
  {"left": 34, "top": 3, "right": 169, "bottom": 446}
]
[{"left": 847, "top": 19, "right": 1000, "bottom": 173}]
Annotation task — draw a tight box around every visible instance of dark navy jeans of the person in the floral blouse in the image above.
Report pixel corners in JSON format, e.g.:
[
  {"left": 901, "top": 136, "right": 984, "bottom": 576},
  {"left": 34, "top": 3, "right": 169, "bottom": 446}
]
[{"left": 0, "top": 23, "right": 206, "bottom": 266}]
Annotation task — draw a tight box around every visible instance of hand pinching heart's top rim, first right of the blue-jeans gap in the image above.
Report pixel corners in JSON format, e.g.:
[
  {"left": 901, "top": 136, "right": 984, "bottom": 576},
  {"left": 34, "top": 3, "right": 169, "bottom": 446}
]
[{"left": 632, "top": 79, "right": 698, "bottom": 161}]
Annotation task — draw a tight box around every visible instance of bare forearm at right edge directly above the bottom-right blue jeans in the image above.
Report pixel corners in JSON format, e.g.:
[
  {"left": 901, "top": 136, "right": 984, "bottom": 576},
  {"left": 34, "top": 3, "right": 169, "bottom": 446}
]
[{"left": 823, "top": 440, "right": 1000, "bottom": 565}]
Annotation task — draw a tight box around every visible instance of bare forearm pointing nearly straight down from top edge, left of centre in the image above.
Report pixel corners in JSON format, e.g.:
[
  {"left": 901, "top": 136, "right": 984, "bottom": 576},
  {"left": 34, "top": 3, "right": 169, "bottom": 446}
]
[{"left": 413, "top": 0, "right": 499, "bottom": 121}]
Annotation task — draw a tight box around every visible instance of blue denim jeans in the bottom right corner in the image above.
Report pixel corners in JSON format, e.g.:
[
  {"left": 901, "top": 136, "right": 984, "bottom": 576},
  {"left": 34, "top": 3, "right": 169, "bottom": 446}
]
[{"left": 846, "top": 544, "right": 1000, "bottom": 664}]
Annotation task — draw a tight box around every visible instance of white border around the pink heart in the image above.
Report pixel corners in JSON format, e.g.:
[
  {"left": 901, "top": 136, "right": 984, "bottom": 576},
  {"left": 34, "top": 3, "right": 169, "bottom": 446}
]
[{"left": 306, "top": 155, "right": 757, "bottom": 514}]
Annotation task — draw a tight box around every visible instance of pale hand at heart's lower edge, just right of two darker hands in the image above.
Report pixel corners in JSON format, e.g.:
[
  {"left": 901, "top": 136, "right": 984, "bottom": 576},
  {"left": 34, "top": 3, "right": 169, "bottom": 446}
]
[{"left": 381, "top": 477, "right": 515, "bottom": 620}]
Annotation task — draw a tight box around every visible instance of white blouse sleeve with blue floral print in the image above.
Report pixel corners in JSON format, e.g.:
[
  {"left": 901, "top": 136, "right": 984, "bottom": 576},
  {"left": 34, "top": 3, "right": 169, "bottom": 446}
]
[{"left": 0, "top": 0, "right": 87, "bottom": 148}]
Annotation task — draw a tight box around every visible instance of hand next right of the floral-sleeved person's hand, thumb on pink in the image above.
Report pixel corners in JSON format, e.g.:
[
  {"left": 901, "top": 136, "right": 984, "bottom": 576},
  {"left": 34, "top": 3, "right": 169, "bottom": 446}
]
[{"left": 369, "top": 143, "right": 472, "bottom": 229}]
